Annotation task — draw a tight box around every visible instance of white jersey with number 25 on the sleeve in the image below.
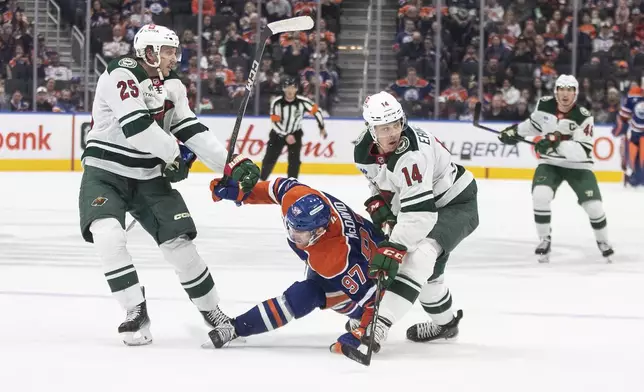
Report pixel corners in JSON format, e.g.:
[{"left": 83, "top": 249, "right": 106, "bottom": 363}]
[{"left": 82, "top": 56, "right": 226, "bottom": 180}]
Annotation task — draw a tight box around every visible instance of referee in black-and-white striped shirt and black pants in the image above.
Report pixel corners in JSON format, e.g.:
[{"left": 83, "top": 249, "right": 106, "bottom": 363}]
[{"left": 260, "top": 76, "right": 327, "bottom": 181}]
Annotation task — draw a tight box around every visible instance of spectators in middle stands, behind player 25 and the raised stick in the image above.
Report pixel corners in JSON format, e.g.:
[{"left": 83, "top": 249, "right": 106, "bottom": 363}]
[{"left": 85, "top": 0, "right": 341, "bottom": 114}]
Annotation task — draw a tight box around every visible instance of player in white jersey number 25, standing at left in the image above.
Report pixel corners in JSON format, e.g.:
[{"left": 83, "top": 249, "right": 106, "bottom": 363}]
[{"left": 79, "top": 25, "right": 259, "bottom": 345}]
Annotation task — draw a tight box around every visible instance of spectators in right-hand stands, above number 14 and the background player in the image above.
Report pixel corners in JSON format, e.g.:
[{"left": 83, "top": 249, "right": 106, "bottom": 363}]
[{"left": 390, "top": 0, "right": 644, "bottom": 122}]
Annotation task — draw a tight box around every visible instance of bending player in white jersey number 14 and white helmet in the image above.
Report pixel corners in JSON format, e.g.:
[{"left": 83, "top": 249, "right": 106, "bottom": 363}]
[{"left": 354, "top": 92, "right": 479, "bottom": 350}]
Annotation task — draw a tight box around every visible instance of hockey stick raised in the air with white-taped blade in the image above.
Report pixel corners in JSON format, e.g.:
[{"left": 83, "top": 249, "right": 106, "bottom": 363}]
[{"left": 222, "top": 16, "right": 313, "bottom": 178}]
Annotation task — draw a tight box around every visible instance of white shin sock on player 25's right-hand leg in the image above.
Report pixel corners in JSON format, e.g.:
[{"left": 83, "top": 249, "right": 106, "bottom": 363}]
[{"left": 159, "top": 235, "right": 219, "bottom": 312}]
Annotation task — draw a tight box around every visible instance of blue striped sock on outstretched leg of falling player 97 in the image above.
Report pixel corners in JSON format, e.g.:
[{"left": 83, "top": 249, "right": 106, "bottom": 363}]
[{"left": 233, "top": 280, "right": 326, "bottom": 336}]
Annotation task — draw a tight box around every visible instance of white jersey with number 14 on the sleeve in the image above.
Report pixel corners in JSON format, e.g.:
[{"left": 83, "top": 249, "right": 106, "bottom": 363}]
[{"left": 354, "top": 125, "right": 474, "bottom": 251}]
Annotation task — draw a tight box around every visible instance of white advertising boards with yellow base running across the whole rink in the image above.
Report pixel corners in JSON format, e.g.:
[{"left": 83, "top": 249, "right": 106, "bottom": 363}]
[{"left": 5, "top": 114, "right": 621, "bottom": 181}]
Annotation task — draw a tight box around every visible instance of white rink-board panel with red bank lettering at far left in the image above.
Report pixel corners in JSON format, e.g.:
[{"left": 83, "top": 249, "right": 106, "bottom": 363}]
[{"left": 0, "top": 113, "right": 74, "bottom": 170}]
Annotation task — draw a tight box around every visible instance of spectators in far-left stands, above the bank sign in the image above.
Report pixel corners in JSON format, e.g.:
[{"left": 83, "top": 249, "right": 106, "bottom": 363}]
[{"left": 0, "top": 0, "right": 83, "bottom": 112}]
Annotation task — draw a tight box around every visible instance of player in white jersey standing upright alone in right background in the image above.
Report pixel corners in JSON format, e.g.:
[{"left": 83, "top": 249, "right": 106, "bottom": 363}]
[{"left": 499, "top": 75, "right": 614, "bottom": 262}]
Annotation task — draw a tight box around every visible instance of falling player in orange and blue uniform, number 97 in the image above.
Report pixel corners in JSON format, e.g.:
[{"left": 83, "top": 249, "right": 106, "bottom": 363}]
[{"left": 210, "top": 178, "right": 384, "bottom": 353}]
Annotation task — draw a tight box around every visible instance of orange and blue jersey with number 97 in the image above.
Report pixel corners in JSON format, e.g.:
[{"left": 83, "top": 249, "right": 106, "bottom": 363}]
[{"left": 244, "top": 178, "right": 384, "bottom": 313}]
